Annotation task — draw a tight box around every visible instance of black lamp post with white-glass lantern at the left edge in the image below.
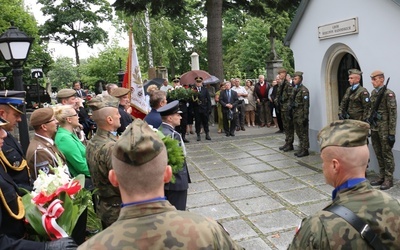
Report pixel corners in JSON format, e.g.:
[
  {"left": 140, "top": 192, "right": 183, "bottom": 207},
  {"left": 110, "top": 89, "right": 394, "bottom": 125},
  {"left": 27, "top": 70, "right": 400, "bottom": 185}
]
[{"left": 0, "top": 23, "right": 33, "bottom": 153}]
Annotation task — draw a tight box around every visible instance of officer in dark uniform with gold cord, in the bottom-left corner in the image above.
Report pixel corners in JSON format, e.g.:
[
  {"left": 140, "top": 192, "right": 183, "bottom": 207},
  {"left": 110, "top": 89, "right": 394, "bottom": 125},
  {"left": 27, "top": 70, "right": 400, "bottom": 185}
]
[{"left": 0, "top": 118, "right": 78, "bottom": 250}]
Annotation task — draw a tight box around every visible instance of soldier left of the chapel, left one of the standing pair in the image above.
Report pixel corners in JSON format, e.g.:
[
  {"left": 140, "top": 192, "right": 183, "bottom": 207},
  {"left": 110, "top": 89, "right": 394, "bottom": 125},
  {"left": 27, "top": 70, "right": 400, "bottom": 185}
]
[{"left": 274, "top": 69, "right": 294, "bottom": 152}]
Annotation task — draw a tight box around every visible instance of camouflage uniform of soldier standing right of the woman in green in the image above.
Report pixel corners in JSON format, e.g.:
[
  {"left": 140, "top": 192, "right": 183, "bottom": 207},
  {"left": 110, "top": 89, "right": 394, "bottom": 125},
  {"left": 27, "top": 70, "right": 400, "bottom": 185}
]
[{"left": 86, "top": 128, "right": 121, "bottom": 226}]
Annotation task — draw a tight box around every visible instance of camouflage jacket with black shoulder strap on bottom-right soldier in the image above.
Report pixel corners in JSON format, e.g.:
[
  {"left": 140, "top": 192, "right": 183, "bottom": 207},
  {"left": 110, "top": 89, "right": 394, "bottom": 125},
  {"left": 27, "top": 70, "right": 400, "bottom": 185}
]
[{"left": 288, "top": 181, "right": 400, "bottom": 250}]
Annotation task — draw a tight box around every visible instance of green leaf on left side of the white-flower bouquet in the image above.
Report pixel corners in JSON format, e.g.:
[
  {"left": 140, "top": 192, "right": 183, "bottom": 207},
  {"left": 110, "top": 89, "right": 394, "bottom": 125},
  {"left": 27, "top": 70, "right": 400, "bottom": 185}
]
[{"left": 22, "top": 194, "right": 49, "bottom": 239}]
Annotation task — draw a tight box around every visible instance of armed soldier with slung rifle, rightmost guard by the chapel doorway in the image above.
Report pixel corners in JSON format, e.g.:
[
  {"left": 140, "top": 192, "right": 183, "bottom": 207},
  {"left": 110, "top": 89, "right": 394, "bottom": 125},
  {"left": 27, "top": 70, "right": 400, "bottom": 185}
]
[{"left": 370, "top": 70, "right": 397, "bottom": 190}]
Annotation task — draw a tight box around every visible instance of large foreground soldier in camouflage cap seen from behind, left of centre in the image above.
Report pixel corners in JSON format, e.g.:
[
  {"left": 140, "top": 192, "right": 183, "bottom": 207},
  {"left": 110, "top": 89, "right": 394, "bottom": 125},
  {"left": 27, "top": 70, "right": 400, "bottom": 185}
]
[{"left": 78, "top": 119, "right": 243, "bottom": 249}]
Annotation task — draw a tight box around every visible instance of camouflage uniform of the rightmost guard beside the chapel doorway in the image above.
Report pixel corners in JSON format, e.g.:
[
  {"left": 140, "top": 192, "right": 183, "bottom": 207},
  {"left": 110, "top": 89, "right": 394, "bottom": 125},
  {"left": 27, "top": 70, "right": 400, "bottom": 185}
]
[{"left": 371, "top": 88, "right": 397, "bottom": 180}]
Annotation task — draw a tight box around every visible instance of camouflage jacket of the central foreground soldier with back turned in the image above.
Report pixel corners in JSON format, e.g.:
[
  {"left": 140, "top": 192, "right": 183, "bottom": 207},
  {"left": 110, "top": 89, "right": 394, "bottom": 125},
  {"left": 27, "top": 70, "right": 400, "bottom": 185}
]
[{"left": 78, "top": 200, "right": 243, "bottom": 249}]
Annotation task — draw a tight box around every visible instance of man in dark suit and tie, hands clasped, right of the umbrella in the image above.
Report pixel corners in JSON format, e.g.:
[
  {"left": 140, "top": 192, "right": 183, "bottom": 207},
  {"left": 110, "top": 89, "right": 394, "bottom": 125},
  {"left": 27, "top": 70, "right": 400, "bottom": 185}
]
[{"left": 219, "top": 81, "right": 239, "bottom": 136}]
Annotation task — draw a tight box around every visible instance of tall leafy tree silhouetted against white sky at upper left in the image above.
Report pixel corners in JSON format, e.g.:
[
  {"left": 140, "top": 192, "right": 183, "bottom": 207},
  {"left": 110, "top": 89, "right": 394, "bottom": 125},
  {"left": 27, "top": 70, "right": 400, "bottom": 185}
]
[{"left": 38, "top": 0, "right": 112, "bottom": 65}]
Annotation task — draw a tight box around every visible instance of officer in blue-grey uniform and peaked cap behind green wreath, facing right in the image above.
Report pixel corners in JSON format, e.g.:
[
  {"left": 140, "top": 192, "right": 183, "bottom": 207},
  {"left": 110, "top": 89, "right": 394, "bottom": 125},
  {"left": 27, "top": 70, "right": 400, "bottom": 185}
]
[{"left": 157, "top": 100, "right": 191, "bottom": 211}]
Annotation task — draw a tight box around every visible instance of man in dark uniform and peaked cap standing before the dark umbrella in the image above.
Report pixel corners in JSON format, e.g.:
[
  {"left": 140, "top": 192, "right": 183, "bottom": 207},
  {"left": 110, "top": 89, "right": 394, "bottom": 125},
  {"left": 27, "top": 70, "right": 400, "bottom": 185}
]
[{"left": 193, "top": 76, "right": 211, "bottom": 141}]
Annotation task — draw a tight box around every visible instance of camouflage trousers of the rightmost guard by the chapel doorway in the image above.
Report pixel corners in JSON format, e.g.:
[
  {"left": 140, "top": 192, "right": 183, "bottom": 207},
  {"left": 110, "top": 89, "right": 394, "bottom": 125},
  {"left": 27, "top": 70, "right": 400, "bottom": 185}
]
[{"left": 371, "top": 131, "right": 394, "bottom": 179}]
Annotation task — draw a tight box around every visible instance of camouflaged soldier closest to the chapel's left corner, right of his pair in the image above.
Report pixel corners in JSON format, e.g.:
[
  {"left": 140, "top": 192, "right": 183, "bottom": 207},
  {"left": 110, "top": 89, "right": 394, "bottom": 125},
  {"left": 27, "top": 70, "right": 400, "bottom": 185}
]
[{"left": 291, "top": 71, "right": 310, "bottom": 157}]
